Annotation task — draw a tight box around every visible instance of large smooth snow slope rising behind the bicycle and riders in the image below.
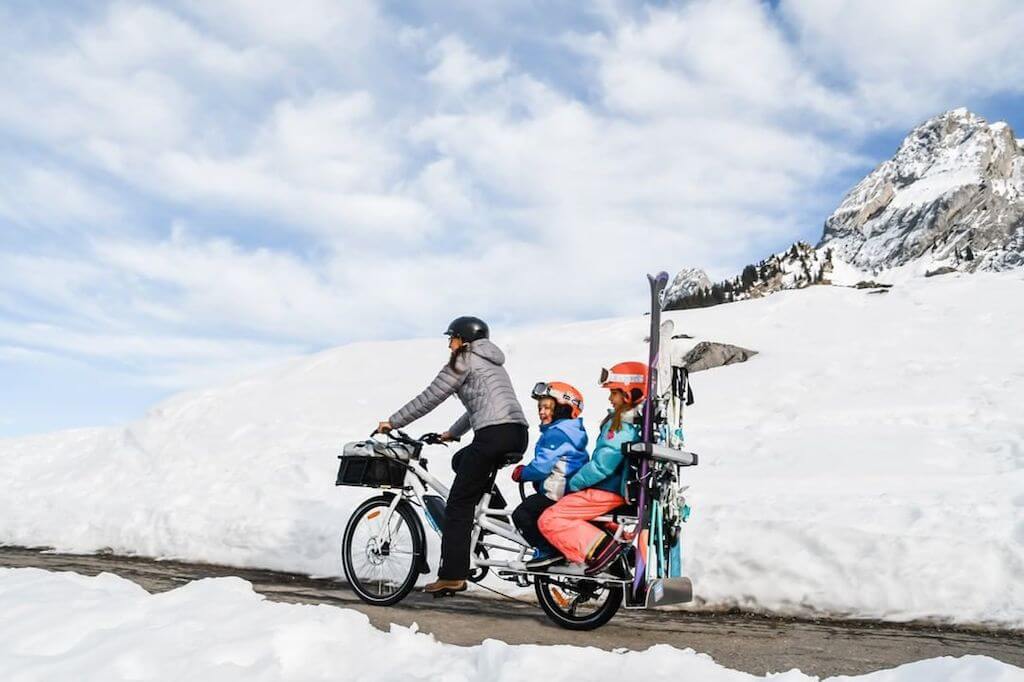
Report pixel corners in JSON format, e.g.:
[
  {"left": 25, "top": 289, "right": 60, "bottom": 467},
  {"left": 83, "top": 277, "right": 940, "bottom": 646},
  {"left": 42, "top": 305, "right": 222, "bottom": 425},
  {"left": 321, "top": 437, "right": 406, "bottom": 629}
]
[{"left": 0, "top": 270, "right": 1024, "bottom": 628}]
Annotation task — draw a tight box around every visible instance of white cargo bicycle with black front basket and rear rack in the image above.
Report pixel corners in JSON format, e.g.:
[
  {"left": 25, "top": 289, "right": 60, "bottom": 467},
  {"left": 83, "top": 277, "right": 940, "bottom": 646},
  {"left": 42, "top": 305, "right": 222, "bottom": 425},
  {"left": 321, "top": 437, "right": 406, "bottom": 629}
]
[{"left": 336, "top": 430, "right": 697, "bottom": 630}]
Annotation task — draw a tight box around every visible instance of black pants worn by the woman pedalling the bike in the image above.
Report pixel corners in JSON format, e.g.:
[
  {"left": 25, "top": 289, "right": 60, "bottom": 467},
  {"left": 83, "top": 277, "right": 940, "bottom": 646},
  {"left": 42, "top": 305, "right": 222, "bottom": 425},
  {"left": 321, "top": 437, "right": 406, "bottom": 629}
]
[{"left": 437, "top": 424, "right": 529, "bottom": 581}]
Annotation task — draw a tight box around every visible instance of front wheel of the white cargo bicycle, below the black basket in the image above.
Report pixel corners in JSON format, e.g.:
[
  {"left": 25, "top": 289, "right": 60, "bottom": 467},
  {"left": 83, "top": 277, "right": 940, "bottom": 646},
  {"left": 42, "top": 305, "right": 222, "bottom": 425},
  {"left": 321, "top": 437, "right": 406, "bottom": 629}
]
[{"left": 341, "top": 496, "right": 426, "bottom": 606}]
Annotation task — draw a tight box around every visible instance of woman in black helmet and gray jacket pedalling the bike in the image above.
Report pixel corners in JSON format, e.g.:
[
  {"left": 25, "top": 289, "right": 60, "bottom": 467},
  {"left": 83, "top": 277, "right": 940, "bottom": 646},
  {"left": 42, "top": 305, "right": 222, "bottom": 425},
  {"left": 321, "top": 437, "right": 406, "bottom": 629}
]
[{"left": 378, "top": 316, "right": 528, "bottom": 596}]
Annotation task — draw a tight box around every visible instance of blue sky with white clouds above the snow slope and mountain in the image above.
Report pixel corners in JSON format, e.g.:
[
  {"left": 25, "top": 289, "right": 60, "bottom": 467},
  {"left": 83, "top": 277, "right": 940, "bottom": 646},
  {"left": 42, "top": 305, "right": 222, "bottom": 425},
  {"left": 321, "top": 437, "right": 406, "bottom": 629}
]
[{"left": 0, "top": 0, "right": 1024, "bottom": 436}]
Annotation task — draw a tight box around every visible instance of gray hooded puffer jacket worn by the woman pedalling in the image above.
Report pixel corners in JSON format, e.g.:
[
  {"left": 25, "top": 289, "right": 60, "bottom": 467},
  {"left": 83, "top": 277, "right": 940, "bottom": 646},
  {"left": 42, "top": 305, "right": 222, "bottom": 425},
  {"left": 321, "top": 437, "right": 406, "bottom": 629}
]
[{"left": 388, "top": 339, "right": 526, "bottom": 437}]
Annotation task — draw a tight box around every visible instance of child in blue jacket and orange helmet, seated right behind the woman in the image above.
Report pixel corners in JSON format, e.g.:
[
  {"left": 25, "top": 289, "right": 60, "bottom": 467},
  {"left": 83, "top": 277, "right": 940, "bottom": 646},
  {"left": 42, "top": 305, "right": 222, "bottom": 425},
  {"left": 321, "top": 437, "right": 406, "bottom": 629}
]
[{"left": 512, "top": 381, "right": 589, "bottom": 561}]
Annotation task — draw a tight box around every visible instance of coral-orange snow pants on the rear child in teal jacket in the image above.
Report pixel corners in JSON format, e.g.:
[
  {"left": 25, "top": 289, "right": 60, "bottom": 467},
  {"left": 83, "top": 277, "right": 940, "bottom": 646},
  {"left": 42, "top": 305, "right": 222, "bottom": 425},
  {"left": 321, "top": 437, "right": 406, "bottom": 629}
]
[{"left": 537, "top": 487, "right": 626, "bottom": 563}]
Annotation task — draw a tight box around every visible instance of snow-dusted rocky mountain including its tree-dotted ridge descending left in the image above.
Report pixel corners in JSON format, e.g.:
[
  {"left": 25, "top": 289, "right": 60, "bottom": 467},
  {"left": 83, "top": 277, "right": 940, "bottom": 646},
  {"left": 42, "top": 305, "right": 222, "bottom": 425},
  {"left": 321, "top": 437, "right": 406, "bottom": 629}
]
[{"left": 665, "top": 109, "right": 1024, "bottom": 309}]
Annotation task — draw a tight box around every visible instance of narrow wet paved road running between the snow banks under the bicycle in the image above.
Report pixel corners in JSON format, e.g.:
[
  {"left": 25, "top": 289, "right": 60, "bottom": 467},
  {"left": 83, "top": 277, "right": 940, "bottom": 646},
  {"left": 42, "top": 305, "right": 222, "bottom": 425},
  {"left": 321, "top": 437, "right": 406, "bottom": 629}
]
[{"left": 0, "top": 547, "right": 1024, "bottom": 676}]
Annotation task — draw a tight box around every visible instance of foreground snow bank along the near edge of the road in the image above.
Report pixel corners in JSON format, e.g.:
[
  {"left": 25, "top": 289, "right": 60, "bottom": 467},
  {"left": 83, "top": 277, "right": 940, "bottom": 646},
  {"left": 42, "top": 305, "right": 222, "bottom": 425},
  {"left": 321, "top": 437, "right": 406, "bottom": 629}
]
[{"left": 0, "top": 568, "right": 1024, "bottom": 682}]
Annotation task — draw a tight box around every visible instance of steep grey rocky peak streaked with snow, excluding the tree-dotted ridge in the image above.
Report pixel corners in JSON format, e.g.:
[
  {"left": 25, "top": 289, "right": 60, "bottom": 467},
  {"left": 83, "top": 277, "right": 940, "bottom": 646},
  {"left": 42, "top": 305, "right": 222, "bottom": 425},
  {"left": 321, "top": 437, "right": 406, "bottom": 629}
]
[{"left": 818, "top": 109, "right": 1024, "bottom": 273}]
